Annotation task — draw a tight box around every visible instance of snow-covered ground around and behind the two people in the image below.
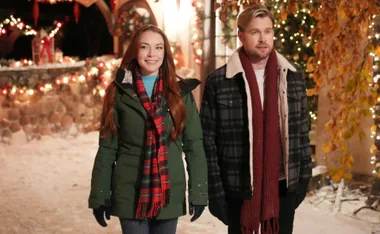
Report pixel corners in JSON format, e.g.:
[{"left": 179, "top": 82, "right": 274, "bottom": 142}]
[{"left": 0, "top": 132, "right": 380, "bottom": 234}]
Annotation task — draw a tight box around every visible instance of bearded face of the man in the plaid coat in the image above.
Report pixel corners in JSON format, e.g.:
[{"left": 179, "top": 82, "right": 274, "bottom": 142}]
[{"left": 238, "top": 17, "right": 274, "bottom": 61}]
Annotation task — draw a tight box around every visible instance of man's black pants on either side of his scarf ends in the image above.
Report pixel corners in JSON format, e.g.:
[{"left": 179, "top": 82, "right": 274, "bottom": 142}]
[{"left": 227, "top": 180, "right": 295, "bottom": 234}]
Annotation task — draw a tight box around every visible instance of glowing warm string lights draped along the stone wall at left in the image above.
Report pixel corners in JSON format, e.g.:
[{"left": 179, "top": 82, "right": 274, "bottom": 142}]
[{"left": 0, "top": 59, "right": 119, "bottom": 97}]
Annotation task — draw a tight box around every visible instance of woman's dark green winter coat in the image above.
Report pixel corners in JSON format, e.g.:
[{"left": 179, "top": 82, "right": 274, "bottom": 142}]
[{"left": 89, "top": 70, "right": 208, "bottom": 219}]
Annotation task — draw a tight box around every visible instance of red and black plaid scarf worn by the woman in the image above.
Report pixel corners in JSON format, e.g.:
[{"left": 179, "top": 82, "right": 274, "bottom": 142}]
[{"left": 133, "top": 72, "right": 170, "bottom": 219}]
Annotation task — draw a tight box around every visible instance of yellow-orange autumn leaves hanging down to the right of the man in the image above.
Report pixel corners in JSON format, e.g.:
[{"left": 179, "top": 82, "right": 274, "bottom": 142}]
[{"left": 307, "top": 0, "right": 380, "bottom": 182}]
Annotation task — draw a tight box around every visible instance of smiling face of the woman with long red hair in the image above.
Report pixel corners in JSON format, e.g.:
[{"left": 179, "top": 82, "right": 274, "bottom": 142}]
[{"left": 137, "top": 31, "right": 165, "bottom": 76}]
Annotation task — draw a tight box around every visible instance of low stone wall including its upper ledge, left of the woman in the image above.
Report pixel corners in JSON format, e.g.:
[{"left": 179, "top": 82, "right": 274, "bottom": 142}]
[{"left": 0, "top": 61, "right": 102, "bottom": 144}]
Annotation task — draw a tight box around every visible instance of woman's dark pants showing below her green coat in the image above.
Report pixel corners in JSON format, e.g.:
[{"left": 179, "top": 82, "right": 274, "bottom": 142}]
[{"left": 120, "top": 218, "right": 178, "bottom": 234}]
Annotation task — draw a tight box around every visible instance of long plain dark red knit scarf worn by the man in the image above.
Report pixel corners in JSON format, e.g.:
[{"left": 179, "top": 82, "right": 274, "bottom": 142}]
[{"left": 239, "top": 47, "right": 281, "bottom": 234}]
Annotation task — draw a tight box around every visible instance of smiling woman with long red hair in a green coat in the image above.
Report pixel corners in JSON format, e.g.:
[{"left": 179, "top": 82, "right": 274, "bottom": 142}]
[{"left": 89, "top": 25, "right": 208, "bottom": 234}]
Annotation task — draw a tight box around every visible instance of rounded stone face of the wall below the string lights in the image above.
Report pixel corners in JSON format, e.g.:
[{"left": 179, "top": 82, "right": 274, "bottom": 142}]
[{"left": 0, "top": 84, "right": 102, "bottom": 144}]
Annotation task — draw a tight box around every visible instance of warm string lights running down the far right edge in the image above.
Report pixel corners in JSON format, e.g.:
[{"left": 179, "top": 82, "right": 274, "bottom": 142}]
[{"left": 368, "top": 16, "right": 380, "bottom": 179}]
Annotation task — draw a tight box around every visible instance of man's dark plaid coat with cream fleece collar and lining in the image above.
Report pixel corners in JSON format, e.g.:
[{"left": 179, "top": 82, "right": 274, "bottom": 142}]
[{"left": 200, "top": 48, "right": 311, "bottom": 199}]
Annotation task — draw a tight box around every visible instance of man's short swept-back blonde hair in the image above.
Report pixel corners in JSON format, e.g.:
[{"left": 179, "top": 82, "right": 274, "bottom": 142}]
[{"left": 237, "top": 4, "right": 274, "bottom": 32}]
